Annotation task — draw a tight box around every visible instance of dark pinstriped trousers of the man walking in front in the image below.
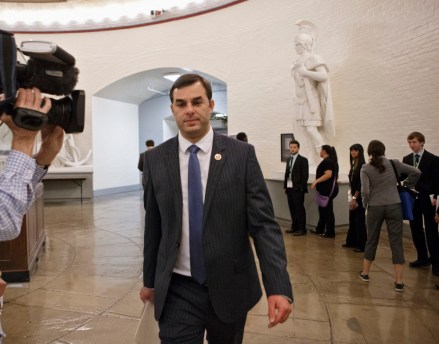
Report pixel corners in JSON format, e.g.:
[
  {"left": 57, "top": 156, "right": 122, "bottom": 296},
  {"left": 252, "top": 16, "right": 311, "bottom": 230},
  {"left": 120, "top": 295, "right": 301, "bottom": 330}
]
[{"left": 159, "top": 274, "right": 247, "bottom": 344}]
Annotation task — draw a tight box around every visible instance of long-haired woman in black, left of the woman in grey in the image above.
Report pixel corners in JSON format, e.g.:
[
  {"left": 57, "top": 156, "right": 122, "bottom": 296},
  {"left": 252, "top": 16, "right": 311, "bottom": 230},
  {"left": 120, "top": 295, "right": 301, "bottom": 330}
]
[{"left": 342, "top": 143, "right": 367, "bottom": 252}]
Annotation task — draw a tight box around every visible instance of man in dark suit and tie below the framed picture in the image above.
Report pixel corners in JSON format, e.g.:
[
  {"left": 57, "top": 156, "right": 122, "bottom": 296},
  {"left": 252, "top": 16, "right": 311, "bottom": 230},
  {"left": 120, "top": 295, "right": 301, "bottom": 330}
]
[{"left": 284, "top": 140, "right": 309, "bottom": 235}]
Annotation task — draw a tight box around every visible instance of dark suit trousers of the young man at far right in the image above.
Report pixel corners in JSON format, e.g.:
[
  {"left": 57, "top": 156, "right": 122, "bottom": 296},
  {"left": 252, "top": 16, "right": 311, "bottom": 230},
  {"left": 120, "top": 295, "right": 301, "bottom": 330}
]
[{"left": 410, "top": 194, "right": 439, "bottom": 269}]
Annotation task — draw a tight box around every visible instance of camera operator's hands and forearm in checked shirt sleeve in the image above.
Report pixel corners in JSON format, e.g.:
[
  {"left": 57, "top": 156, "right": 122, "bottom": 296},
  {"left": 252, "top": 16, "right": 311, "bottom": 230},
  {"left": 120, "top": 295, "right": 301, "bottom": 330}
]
[{"left": 0, "top": 89, "right": 56, "bottom": 241}]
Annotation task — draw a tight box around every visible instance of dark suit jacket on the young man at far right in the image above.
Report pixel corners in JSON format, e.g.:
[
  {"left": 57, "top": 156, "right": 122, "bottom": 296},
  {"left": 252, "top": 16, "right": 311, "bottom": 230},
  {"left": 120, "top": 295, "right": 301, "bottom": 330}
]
[{"left": 401, "top": 150, "right": 439, "bottom": 195}]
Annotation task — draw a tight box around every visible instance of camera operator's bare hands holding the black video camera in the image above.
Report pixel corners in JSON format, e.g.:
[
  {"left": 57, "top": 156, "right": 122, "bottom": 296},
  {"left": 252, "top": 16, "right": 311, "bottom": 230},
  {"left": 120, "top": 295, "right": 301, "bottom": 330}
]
[{"left": 0, "top": 88, "right": 52, "bottom": 156}]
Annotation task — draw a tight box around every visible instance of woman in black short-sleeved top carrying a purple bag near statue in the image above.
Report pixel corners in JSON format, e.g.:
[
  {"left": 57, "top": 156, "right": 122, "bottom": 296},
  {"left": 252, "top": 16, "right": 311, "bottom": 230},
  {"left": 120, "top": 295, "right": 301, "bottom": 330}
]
[{"left": 311, "top": 145, "right": 338, "bottom": 238}]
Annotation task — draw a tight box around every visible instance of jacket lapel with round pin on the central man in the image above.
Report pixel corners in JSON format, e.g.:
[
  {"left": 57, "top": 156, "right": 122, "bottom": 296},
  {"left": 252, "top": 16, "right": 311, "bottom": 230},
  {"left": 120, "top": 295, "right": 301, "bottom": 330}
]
[{"left": 203, "top": 133, "right": 227, "bottom": 224}]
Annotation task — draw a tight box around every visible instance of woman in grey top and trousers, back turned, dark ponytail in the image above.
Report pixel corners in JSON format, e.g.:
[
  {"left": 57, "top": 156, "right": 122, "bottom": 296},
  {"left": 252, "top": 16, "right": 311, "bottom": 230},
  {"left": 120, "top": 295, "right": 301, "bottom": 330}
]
[{"left": 358, "top": 140, "right": 421, "bottom": 292}]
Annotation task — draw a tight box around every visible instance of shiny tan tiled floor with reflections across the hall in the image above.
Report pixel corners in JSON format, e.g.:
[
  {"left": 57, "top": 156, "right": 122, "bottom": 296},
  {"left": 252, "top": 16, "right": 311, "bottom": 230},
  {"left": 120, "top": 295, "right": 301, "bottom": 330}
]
[{"left": 1, "top": 191, "right": 439, "bottom": 344}]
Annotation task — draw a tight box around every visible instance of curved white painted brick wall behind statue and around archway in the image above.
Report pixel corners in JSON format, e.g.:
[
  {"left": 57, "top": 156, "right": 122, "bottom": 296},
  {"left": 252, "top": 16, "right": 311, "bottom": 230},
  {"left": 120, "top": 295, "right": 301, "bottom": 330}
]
[{"left": 17, "top": 0, "right": 439, "bottom": 191}]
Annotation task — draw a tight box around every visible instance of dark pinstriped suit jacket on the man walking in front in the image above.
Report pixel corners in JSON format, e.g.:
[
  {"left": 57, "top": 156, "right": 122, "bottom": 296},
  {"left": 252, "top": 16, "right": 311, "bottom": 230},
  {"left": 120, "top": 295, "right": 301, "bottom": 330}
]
[{"left": 143, "top": 134, "right": 293, "bottom": 322}]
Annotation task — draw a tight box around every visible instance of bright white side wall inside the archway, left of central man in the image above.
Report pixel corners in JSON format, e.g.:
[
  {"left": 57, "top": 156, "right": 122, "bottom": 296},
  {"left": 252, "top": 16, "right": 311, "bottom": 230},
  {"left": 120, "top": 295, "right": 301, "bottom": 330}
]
[{"left": 92, "top": 97, "right": 139, "bottom": 191}]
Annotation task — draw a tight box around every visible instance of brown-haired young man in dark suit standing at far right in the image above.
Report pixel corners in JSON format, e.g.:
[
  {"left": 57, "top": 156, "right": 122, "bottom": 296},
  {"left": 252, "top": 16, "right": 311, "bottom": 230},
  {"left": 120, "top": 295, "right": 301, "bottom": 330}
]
[{"left": 402, "top": 132, "right": 439, "bottom": 275}]
